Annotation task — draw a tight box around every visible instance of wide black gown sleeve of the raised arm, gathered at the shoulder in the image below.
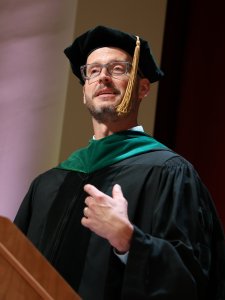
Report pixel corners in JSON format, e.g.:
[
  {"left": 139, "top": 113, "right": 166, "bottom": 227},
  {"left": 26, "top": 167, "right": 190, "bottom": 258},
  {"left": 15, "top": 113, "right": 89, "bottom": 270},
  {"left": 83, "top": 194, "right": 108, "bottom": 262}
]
[{"left": 119, "top": 158, "right": 225, "bottom": 300}]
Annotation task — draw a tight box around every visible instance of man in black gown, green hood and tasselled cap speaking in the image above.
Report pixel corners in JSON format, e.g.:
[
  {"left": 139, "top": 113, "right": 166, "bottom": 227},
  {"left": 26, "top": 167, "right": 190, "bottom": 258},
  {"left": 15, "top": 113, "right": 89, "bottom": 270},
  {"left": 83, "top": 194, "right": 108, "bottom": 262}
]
[{"left": 15, "top": 26, "right": 225, "bottom": 300}]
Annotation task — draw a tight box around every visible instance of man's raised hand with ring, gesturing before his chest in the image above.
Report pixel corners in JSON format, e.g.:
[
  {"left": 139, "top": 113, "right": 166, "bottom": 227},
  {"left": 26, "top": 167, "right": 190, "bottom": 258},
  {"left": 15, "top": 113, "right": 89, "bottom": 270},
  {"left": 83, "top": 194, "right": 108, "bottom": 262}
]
[{"left": 81, "top": 184, "right": 133, "bottom": 252}]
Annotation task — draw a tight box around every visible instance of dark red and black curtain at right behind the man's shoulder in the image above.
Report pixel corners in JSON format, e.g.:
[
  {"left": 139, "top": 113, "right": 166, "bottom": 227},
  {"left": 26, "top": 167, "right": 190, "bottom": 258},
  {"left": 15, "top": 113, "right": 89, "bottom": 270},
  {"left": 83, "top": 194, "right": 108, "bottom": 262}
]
[{"left": 154, "top": 0, "right": 225, "bottom": 227}]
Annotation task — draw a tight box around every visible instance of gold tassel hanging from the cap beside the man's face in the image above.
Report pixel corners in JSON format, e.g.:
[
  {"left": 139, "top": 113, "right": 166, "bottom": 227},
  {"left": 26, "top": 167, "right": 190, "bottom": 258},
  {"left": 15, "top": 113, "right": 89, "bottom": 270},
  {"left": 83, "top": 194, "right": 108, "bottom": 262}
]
[{"left": 116, "top": 36, "right": 140, "bottom": 115}]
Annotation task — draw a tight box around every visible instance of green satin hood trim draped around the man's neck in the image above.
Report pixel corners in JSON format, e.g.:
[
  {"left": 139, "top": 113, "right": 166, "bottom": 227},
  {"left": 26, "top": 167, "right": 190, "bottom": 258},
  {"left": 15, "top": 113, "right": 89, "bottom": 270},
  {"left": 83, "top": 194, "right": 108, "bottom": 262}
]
[{"left": 57, "top": 130, "right": 168, "bottom": 174}]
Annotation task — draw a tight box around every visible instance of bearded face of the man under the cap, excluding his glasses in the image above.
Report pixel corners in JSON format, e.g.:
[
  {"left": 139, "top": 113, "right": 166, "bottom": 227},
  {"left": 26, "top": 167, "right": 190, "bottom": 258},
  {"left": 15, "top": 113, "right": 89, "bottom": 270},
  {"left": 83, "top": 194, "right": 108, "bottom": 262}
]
[{"left": 83, "top": 47, "right": 137, "bottom": 121}]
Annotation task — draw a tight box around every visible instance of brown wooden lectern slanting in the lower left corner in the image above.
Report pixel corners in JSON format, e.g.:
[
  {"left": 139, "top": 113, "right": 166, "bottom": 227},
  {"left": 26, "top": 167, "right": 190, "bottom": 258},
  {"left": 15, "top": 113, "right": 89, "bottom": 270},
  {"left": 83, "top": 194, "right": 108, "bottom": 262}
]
[{"left": 0, "top": 217, "right": 81, "bottom": 300}]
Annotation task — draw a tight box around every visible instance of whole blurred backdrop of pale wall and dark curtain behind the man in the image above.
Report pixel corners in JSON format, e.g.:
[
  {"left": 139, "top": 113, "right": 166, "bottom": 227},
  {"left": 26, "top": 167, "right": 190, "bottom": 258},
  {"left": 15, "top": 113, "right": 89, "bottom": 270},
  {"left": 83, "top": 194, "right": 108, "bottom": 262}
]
[{"left": 0, "top": 0, "right": 225, "bottom": 224}]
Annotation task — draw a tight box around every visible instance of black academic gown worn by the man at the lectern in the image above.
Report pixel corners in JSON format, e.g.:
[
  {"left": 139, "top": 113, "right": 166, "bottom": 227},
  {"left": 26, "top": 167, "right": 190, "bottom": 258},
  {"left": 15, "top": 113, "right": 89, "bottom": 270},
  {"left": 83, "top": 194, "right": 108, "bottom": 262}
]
[{"left": 15, "top": 149, "right": 225, "bottom": 300}]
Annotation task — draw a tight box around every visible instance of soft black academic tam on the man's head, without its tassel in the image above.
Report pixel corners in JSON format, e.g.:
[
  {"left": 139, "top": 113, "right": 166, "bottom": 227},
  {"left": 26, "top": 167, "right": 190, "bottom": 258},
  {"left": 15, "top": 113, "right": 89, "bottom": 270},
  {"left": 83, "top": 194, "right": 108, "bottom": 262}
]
[{"left": 64, "top": 26, "right": 163, "bottom": 84}]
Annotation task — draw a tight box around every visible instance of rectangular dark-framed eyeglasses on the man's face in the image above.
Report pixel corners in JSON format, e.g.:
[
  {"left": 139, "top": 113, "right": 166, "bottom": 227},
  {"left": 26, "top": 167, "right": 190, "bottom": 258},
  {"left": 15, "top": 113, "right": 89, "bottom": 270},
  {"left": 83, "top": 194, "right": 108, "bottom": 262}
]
[{"left": 80, "top": 61, "right": 132, "bottom": 80}]
